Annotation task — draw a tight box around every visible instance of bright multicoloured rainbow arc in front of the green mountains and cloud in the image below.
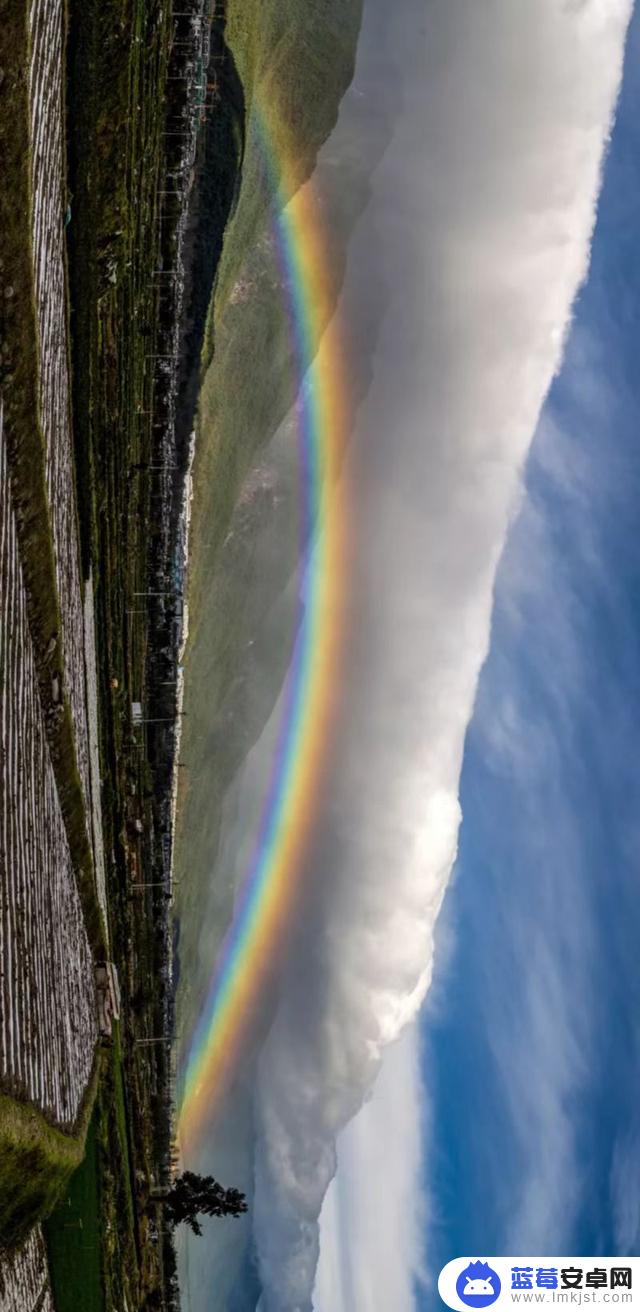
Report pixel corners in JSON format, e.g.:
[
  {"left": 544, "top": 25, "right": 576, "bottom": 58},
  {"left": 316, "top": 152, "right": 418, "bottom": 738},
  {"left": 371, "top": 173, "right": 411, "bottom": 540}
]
[{"left": 178, "top": 104, "right": 349, "bottom": 1152}]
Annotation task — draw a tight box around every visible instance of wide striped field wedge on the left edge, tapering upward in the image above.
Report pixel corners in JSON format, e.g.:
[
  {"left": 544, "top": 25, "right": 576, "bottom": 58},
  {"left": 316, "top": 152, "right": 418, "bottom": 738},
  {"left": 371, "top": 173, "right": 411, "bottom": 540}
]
[{"left": 0, "top": 404, "right": 97, "bottom": 1128}]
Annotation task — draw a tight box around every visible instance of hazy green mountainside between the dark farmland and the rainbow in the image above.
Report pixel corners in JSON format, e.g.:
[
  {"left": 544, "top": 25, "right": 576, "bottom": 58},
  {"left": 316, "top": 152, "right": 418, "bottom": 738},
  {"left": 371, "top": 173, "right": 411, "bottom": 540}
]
[{"left": 176, "top": 0, "right": 401, "bottom": 1065}]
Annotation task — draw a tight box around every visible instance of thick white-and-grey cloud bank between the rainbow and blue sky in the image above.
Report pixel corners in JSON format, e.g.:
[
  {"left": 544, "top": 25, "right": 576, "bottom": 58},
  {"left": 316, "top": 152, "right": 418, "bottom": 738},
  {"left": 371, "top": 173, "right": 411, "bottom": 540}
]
[{"left": 241, "top": 0, "right": 631, "bottom": 1312}]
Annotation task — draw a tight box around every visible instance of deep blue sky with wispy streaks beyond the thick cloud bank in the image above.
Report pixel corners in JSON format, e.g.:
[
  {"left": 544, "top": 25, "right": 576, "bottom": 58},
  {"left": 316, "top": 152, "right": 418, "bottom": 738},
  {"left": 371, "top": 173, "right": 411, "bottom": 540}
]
[{"left": 422, "top": 12, "right": 640, "bottom": 1308}]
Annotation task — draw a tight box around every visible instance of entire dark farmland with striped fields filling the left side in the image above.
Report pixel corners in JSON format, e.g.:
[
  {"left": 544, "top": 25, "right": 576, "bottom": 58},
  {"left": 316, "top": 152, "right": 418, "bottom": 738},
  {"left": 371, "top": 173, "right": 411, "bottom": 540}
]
[{"left": 0, "top": 0, "right": 204, "bottom": 1280}]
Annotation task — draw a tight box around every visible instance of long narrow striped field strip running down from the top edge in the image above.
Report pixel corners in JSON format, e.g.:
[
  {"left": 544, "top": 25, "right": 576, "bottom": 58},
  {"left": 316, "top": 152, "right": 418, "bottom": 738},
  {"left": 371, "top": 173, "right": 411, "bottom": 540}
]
[{"left": 29, "top": 0, "right": 90, "bottom": 807}]
